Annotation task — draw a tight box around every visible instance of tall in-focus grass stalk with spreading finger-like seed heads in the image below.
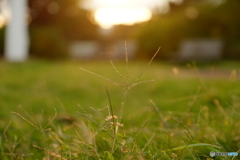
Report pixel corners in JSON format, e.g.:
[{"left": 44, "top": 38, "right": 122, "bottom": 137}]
[{"left": 78, "top": 46, "right": 160, "bottom": 158}]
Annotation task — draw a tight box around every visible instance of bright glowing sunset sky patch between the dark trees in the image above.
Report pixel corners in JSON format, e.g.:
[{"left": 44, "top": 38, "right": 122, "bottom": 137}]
[{"left": 84, "top": 0, "right": 181, "bottom": 29}]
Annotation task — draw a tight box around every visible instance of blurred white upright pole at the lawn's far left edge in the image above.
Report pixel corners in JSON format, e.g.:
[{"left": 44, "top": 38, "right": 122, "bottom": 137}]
[{"left": 5, "top": 0, "right": 29, "bottom": 62}]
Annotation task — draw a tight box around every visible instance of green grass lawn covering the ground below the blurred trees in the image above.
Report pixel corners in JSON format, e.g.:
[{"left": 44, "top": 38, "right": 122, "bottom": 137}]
[{"left": 0, "top": 60, "right": 240, "bottom": 160}]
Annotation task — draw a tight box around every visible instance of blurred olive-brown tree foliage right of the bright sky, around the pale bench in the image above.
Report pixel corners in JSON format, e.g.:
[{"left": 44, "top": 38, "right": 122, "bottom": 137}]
[{"left": 134, "top": 0, "right": 240, "bottom": 59}]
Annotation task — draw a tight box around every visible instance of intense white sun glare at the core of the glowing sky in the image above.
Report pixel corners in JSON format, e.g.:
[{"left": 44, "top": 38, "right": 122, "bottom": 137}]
[{"left": 94, "top": 7, "right": 152, "bottom": 29}]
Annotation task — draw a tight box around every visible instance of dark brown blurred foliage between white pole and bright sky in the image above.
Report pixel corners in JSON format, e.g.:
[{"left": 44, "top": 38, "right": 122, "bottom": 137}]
[{"left": 29, "top": 0, "right": 99, "bottom": 58}]
